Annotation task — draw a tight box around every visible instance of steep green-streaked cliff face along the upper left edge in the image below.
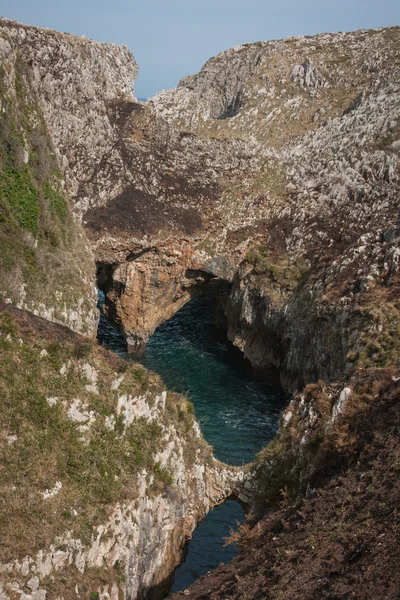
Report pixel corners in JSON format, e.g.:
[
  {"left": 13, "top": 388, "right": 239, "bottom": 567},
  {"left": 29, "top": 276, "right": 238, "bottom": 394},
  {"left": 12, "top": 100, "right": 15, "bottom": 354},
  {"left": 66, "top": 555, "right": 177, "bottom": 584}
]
[{"left": 0, "top": 20, "right": 98, "bottom": 335}]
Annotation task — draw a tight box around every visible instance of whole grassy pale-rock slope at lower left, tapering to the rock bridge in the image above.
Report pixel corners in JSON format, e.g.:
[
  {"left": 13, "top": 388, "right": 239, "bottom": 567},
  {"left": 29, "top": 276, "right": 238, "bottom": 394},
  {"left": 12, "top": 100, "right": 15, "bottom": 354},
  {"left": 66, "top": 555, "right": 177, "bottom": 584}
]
[{"left": 0, "top": 305, "right": 247, "bottom": 600}]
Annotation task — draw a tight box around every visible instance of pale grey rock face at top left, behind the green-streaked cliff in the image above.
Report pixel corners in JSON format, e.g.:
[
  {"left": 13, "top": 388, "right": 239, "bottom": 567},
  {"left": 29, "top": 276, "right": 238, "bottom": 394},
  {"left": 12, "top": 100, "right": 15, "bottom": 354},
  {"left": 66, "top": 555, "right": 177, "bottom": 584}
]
[{"left": 1, "top": 20, "right": 138, "bottom": 212}]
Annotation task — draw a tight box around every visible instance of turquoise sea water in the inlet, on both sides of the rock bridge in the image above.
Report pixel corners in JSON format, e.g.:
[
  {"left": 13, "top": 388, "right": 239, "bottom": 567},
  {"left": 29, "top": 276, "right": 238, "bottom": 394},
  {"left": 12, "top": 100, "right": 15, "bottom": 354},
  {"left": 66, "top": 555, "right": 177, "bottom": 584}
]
[{"left": 98, "top": 298, "right": 284, "bottom": 592}]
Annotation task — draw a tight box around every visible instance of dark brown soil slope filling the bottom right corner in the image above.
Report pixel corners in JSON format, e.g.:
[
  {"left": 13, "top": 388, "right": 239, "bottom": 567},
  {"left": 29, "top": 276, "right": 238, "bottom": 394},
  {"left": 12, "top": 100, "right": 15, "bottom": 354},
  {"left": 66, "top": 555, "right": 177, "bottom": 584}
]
[{"left": 173, "top": 376, "right": 400, "bottom": 600}]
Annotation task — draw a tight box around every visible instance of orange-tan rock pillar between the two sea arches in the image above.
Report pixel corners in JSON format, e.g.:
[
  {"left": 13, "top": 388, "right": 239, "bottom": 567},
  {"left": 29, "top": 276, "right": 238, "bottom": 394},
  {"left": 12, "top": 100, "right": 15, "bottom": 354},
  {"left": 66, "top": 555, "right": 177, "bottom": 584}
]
[{"left": 97, "top": 239, "right": 234, "bottom": 352}]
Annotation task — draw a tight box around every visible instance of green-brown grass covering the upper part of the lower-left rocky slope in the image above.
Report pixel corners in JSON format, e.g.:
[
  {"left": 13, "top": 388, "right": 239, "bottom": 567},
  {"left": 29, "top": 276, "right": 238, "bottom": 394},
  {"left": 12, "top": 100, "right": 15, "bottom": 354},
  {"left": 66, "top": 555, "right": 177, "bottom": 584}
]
[{"left": 0, "top": 312, "right": 211, "bottom": 561}]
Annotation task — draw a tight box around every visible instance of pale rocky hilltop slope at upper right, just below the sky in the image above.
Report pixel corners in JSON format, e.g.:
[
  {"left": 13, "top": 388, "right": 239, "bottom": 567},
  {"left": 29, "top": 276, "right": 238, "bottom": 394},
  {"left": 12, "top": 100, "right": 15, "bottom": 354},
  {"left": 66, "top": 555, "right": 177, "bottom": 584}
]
[{"left": 150, "top": 27, "right": 399, "bottom": 148}]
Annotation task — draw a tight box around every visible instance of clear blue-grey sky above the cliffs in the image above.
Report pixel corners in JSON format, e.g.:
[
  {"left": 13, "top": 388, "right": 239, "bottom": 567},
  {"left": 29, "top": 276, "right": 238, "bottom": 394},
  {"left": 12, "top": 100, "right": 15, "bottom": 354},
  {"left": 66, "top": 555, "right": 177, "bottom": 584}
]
[{"left": 0, "top": 0, "right": 400, "bottom": 98}]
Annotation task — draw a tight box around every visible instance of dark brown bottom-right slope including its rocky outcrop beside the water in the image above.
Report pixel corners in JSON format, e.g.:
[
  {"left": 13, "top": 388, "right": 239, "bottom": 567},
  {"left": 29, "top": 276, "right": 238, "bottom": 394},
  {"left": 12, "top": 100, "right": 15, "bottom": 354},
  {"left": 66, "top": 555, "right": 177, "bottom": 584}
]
[{"left": 171, "top": 371, "right": 400, "bottom": 600}]
